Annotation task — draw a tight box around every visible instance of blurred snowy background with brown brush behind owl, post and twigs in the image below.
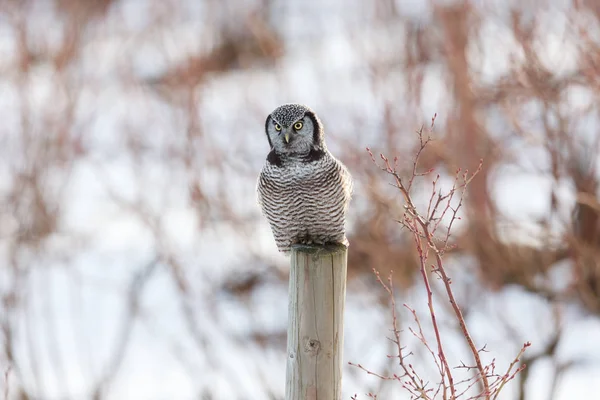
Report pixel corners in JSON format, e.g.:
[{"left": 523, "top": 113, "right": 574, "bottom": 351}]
[{"left": 0, "top": 0, "right": 600, "bottom": 400}]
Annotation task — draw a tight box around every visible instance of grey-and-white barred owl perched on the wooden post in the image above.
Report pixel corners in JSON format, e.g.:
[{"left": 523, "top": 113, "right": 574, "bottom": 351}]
[{"left": 257, "top": 104, "right": 352, "bottom": 253}]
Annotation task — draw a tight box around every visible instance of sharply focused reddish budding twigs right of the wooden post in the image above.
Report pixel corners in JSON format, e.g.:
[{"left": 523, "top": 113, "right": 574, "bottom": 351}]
[{"left": 357, "top": 121, "right": 528, "bottom": 400}]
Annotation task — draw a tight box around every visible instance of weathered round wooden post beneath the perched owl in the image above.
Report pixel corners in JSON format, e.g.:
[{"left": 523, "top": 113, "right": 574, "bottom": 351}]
[{"left": 285, "top": 245, "right": 348, "bottom": 400}]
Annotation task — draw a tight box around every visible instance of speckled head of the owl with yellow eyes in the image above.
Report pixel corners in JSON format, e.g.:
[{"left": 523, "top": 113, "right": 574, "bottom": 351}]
[{"left": 265, "top": 104, "right": 325, "bottom": 154}]
